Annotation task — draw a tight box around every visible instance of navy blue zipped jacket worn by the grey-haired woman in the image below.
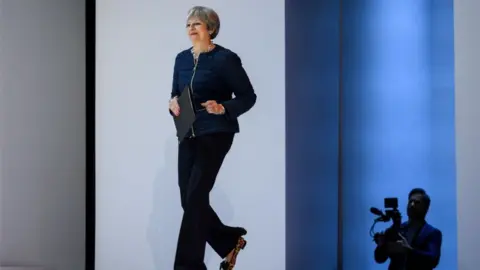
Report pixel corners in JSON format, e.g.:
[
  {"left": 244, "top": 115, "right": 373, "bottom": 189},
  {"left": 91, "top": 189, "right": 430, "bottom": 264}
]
[{"left": 171, "top": 45, "right": 257, "bottom": 137}]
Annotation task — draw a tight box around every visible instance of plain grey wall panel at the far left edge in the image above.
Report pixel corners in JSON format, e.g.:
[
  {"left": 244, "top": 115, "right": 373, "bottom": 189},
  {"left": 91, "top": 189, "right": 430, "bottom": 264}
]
[{"left": 0, "top": 0, "right": 85, "bottom": 270}]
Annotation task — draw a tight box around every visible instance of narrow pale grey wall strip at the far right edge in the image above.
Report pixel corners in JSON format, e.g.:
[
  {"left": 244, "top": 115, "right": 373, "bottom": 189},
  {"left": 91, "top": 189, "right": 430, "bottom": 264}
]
[{"left": 455, "top": 0, "right": 480, "bottom": 270}]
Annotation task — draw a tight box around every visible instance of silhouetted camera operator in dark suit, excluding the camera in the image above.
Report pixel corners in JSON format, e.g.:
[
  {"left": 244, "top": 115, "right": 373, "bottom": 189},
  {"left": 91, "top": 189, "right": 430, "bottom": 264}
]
[{"left": 375, "top": 188, "right": 442, "bottom": 270}]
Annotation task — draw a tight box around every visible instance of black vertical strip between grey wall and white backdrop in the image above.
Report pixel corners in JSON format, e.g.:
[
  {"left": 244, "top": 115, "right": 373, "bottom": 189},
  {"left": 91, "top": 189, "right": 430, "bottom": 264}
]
[{"left": 85, "top": 0, "right": 96, "bottom": 270}]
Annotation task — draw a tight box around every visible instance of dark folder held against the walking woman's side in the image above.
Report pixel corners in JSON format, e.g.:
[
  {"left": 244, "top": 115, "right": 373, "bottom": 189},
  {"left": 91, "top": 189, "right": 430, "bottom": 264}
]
[{"left": 173, "top": 86, "right": 195, "bottom": 141}]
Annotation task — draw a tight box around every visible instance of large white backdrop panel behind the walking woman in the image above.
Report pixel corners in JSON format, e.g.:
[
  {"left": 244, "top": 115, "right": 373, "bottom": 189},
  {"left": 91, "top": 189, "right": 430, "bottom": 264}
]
[{"left": 96, "top": 0, "right": 285, "bottom": 270}]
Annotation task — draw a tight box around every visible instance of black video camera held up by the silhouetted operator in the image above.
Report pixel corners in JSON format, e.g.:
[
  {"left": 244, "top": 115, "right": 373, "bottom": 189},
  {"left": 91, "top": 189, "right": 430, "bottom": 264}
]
[{"left": 370, "top": 198, "right": 402, "bottom": 244}]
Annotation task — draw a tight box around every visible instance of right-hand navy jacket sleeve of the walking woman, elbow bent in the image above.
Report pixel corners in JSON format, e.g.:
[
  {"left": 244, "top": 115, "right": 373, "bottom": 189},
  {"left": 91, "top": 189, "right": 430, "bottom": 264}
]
[{"left": 222, "top": 53, "right": 257, "bottom": 119}]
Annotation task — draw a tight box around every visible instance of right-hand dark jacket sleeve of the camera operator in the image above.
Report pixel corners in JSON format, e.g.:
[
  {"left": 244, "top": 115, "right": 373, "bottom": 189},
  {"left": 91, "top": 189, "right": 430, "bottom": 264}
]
[{"left": 410, "top": 229, "right": 442, "bottom": 269}]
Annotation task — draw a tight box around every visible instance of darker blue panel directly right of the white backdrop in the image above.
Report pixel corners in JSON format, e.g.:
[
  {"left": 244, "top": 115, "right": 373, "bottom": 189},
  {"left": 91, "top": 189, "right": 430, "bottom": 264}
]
[{"left": 285, "top": 0, "right": 340, "bottom": 270}]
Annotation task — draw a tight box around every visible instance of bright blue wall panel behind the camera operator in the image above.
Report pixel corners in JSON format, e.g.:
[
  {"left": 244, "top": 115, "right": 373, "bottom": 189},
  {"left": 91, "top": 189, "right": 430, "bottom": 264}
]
[{"left": 342, "top": 0, "right": 456, "bottom": 270}]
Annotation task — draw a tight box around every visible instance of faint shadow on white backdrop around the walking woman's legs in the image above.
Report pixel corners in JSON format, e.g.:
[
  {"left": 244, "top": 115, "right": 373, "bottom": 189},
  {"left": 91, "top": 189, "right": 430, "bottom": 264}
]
[{"left": 147, "top": 136, "right": 234, "bottom": 270}]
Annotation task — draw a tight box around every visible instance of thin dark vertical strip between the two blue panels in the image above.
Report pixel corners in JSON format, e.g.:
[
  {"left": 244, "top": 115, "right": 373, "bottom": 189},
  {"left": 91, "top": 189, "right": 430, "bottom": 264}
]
[{"left": 336, "top": 0, "right": 343, "bottom": 270}]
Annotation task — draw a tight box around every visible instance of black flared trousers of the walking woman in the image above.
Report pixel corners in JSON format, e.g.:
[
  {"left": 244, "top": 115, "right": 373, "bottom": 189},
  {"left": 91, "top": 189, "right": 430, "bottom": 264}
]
[{"left": 174, "top": 133, "right": 239, "bottom": 270}]
